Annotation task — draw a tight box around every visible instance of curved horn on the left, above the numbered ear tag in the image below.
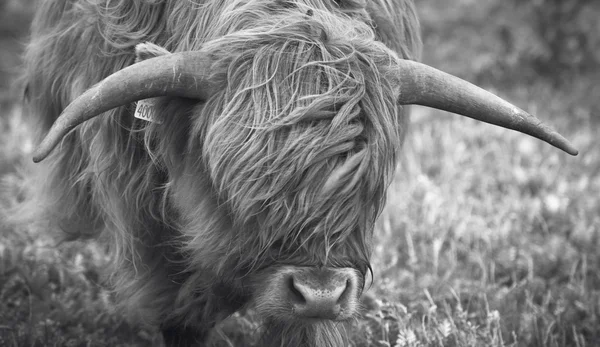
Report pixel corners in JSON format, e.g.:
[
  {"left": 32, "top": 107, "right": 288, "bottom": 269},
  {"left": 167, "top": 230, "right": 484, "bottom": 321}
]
[{"left": 33, "top": 52, "right": 214, "bottom": 163}]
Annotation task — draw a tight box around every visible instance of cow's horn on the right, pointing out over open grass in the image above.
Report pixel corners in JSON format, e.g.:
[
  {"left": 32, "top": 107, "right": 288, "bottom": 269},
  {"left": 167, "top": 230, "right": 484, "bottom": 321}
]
[{"left": 397, "top": 60, "right": 578, "bottom": 155}]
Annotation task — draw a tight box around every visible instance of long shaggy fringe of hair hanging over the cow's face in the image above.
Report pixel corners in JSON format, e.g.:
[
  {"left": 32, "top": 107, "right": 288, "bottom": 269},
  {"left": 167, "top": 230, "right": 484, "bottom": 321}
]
[{"left": 176, "top": 5, "right": 400, "bottom": 274}]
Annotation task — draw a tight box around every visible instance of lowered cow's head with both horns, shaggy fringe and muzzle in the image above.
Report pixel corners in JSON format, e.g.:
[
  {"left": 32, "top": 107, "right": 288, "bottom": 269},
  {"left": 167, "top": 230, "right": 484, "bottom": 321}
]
[{"left": 34, "top": 2, "right": 576, "bottom": 341}]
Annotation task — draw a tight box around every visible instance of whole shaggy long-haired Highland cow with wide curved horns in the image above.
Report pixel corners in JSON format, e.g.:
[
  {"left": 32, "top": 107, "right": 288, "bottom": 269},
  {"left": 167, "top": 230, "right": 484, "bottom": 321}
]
[{"left": 25, "top": 0, "right": 576, "bottom": 346}]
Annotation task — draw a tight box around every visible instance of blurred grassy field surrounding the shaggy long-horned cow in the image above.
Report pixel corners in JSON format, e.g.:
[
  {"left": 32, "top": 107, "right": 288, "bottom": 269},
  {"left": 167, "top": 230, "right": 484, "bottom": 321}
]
[{"left": 0, "top": 0, "right": 600, "bottom": 347}]
